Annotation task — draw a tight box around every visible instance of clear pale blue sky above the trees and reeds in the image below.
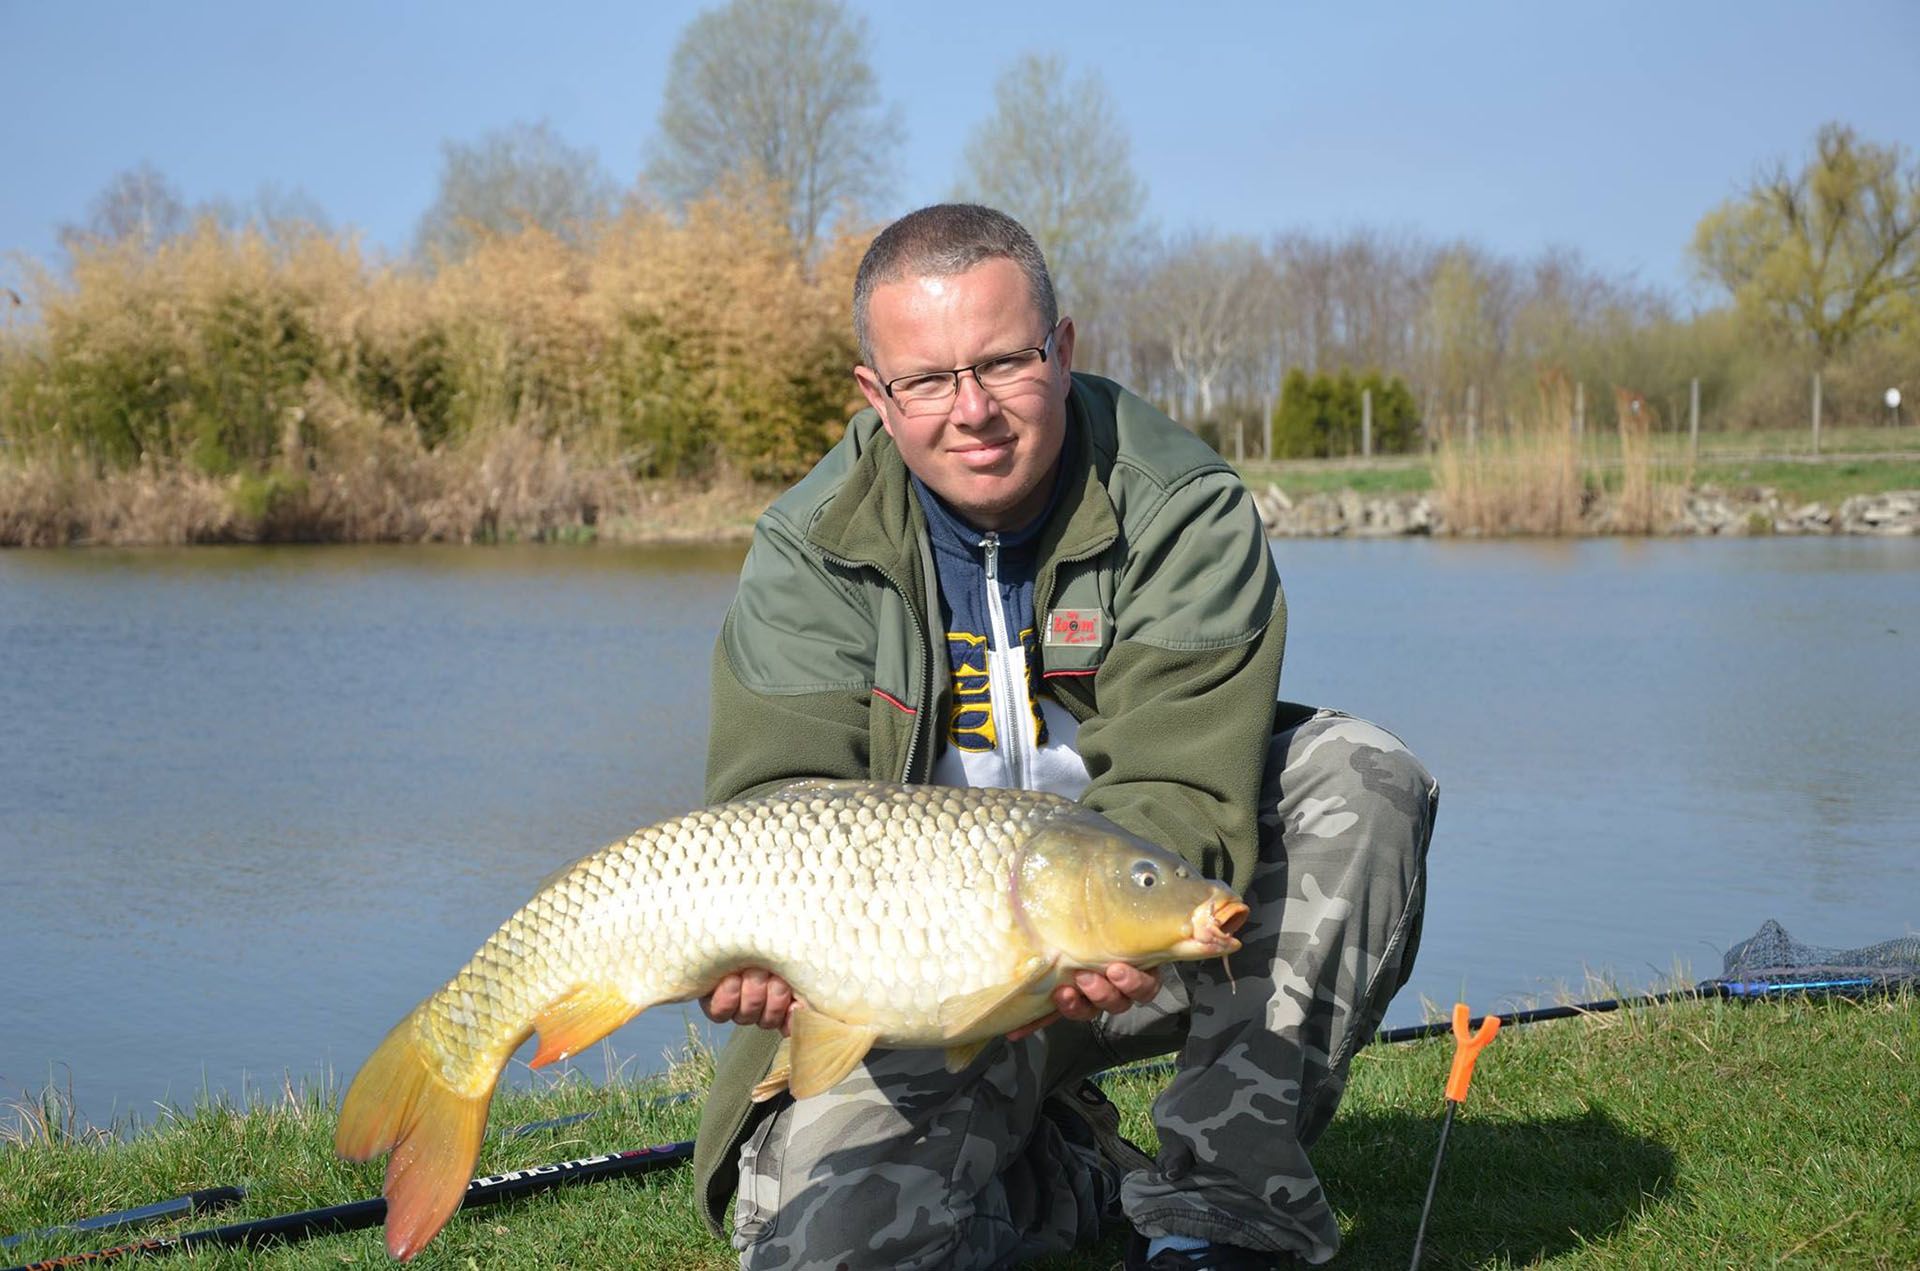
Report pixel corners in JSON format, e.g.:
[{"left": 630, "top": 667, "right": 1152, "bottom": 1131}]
[{"left": 0, "top": 0, "right": 1920, "bottom": 303}]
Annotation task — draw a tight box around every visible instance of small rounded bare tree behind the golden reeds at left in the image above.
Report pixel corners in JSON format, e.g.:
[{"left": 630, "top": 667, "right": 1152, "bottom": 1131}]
[{"left": 415, "top": 121, "right": 614, "bottom": 261}]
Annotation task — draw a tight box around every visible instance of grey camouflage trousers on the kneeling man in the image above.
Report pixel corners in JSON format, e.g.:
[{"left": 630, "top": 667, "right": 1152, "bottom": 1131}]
[{"left": 733, "top": 703, "right": 1438, "bottom": 1271}]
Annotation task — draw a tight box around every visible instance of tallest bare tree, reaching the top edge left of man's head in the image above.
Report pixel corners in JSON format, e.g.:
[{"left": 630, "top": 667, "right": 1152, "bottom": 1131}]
[{"left": 647, "top": 0, "right": 900, "bottom": 255}]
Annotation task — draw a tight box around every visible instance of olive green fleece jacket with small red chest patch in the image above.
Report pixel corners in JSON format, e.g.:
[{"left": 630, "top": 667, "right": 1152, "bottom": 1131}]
[{"left": 695, "top": 374, "right": 1286, "bottom": 1233}]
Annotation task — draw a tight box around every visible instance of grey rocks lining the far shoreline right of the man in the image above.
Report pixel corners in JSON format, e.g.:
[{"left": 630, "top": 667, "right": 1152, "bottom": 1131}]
[{"left": 1254, "top": 484, "right": 1920, "bottom": 538}]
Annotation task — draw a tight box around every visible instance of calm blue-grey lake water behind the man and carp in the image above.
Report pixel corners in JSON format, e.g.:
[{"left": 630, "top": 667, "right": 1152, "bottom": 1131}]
[{"left": 0, "top": 540, "right": 1920, "bottom": 1123}]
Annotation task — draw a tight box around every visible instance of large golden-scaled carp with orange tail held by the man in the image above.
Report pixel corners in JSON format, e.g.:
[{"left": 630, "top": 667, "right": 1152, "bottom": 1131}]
[{"left": 334, "top": 781, "right": 1246, "bottom": 1258}]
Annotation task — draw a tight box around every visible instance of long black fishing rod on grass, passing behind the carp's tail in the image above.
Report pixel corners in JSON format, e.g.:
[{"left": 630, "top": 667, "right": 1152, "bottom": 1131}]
[{"left": 6, "top": 1142, "right": 693, "bottom": 1271}]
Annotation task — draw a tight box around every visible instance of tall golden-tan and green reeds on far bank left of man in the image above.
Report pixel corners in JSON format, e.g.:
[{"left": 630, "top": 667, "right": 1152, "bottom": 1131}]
[{"left": 0, "top": 192, "right": 864, "bottom": 545}]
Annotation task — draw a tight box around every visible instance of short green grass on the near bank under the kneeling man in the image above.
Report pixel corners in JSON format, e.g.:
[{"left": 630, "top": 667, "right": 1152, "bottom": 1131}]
[{"left": 0, "top": 995, "right": 1920, "bottom": 1271}]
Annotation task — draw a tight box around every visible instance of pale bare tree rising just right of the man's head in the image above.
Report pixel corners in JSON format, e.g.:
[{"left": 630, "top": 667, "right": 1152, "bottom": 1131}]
[{"left": 958, "top": 54, "right": 1146, "bottom": 324}]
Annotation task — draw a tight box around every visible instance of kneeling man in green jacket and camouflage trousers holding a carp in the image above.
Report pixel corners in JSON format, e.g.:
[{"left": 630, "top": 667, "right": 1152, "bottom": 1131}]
[{"left": 695, "top": 205, "right": 1436, "bottom": 1271}]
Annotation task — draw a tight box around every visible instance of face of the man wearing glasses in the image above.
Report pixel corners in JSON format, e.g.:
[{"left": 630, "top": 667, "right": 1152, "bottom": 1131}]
[{"left": 854, "top": 257, "right": 1073, "bottom": 530}]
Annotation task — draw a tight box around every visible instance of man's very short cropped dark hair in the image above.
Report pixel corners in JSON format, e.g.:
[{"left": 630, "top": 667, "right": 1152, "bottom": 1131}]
[{"left": 852, "top": 204, "right": 1060, "bottom": 367}]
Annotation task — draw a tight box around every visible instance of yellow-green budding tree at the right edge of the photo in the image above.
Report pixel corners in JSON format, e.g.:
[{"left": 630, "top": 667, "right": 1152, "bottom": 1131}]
[{"left": 1693, "top": 123, "right": 1920, "bottom": 365}]
